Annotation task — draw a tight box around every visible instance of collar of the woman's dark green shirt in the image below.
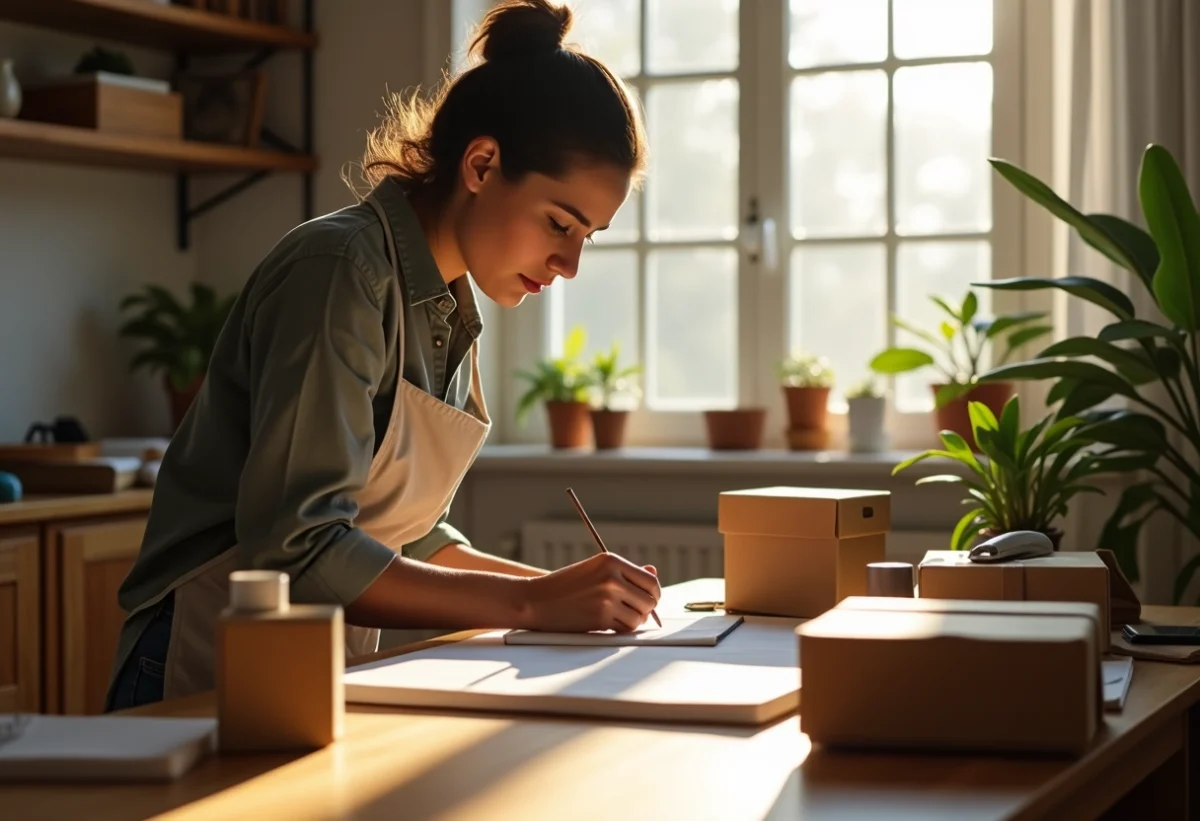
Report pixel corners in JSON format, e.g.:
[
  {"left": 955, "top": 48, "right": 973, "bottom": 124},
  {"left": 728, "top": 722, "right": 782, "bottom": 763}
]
[{"left": 371, "top": 176, "right": 484, "bottom": 337}]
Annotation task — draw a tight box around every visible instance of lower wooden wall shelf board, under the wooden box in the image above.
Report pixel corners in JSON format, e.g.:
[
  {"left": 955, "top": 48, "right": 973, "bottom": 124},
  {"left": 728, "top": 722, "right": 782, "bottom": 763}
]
[{"left": 0, "top": 120, "right": 317, "bottom": 173}]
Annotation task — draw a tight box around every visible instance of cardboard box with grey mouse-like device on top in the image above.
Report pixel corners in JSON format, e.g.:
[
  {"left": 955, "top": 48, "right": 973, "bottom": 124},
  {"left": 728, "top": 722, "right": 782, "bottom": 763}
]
[{"left": 917, "top": 550, "right": 1111, "bottom": 652}]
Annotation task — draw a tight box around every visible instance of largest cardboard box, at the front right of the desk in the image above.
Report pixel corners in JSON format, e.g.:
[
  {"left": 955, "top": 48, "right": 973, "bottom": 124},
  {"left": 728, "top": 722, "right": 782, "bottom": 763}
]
[{"left": 796, "top": 597, "right": 1104, "bottom": 755}]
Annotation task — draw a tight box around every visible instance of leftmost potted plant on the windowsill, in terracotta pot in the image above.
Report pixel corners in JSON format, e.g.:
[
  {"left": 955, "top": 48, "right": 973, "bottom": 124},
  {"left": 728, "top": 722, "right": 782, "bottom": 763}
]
[{"left": 516, "top": 328, "right": 592, "bottom": 448}]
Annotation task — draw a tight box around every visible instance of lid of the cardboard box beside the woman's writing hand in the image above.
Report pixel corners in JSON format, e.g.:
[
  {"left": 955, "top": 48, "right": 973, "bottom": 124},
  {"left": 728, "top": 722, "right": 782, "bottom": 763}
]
[{"left": 718, "top": 486, "right": 892, "bottom": 539}]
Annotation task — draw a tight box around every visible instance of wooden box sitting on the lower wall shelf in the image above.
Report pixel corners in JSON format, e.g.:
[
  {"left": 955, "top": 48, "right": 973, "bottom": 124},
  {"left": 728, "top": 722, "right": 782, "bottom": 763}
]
[{"left": 20, "top": 72, "right": 184, "bottom": 139}]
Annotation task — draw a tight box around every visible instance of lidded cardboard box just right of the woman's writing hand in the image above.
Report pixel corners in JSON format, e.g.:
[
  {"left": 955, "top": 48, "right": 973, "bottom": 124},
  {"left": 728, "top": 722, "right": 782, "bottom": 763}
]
[{"left": 718, "top": 487, "right": 892, "bottom": 618}]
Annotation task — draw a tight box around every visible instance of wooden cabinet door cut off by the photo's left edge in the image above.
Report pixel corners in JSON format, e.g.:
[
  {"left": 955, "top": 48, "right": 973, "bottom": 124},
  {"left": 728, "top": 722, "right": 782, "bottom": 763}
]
[{"left": 0, "top": 529, "right": 42, "bottom": 713}]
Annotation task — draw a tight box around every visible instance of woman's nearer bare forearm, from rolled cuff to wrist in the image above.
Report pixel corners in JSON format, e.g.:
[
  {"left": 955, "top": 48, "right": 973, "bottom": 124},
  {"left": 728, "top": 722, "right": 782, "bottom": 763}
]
[{"left": 346, "top": 551, "right": 532, "bottom": 629}]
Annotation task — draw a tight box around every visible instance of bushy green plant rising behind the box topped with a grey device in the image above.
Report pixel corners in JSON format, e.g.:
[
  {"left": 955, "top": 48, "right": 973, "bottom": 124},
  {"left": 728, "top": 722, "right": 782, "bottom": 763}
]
[{"left": 892, "top": 396, "right": 1147, "bottom": 550}]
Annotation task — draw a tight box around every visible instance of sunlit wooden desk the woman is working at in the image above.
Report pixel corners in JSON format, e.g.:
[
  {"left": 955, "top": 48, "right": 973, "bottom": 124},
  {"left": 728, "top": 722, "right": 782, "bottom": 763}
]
[{"left": 0, "top": 582, "right": 1200, "bottom": 821}]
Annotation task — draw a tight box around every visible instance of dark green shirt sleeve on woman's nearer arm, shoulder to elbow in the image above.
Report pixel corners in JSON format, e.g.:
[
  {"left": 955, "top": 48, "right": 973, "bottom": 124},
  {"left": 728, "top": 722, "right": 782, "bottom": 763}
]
[{"left": 236, "top": 254, "right": 396, "bottom": 606}]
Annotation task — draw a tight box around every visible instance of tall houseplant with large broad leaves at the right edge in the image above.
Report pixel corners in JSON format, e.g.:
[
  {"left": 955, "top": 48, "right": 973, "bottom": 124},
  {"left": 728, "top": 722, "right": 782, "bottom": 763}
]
[{"left": 978, "top": 145, "right": 1200, "bottom": 601}]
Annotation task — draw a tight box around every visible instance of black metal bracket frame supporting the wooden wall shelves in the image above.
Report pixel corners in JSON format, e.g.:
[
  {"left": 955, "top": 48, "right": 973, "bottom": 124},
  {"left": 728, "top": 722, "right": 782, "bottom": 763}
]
[{"left": 175, "top": 0, "right": 314, "bottom": 251}]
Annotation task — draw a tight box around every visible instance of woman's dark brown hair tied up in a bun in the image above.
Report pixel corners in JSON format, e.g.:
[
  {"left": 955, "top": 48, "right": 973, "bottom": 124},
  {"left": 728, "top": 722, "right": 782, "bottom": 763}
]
[{"left": 348, "top": 0, "right": 647, "bottom": 203}]
